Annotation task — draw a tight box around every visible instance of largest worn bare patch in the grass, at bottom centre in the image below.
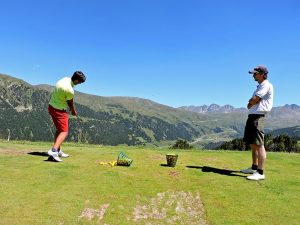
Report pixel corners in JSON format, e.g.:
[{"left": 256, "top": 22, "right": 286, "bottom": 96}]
[{"left": 132, "top": 191, "right": 208, "bottom": 225}]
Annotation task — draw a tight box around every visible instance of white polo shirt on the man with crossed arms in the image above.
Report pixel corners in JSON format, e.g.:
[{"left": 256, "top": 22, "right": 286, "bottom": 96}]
[{"left": 248, "top": 80, "right": 273, "bottom": 115}]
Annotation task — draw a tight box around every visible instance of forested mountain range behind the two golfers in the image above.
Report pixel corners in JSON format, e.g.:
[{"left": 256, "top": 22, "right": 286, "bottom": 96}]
[{"left": 0, "top": 74, "right": 300, "bottom": 145}]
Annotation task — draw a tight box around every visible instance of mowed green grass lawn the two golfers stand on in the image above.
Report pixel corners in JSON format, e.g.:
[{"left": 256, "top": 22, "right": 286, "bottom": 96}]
[{"left": 0, "top": 141, "right": 300, "bottom": 225}]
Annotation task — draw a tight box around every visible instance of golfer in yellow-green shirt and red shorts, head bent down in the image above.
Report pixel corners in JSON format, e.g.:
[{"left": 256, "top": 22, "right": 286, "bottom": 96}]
[{"left": 48, "top": 71, "right": 86, "bottom": 162}]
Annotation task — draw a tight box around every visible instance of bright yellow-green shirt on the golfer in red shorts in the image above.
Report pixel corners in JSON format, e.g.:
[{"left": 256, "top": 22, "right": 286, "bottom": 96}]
[{"left": 49, "top": 77, "right": 75, "bottom": 110}]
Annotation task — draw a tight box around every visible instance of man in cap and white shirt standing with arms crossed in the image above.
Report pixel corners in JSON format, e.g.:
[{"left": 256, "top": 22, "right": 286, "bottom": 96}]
[{"left": 241, "top": 66, "right": 273, "bottom": 180}]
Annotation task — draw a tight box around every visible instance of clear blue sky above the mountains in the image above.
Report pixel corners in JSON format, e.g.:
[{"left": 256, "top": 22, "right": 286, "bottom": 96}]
[{"left": 0, "top": 0, "right": 300, "bottom": 107}]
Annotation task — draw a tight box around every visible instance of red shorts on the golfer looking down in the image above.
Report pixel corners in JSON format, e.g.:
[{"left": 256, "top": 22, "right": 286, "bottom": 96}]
[{"left": 48, "top": 105, "right": 69, "bottom": 132}]
